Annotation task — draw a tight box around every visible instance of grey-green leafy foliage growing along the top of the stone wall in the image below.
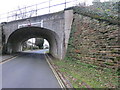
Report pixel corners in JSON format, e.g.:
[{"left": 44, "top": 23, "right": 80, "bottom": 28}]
[{"left": 74, "top": 2, "right": 120, "bottom": 24}]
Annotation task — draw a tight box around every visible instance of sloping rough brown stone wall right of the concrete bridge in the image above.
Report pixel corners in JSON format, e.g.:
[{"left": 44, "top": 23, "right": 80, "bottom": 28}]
[{"left": 66, "top": 13, "right": 120, "bottom": 69}]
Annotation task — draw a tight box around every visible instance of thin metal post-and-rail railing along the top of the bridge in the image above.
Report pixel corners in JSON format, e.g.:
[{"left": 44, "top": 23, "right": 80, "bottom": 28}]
[{"left": 0, "top": 0, "right": 77, "bottom": 23}]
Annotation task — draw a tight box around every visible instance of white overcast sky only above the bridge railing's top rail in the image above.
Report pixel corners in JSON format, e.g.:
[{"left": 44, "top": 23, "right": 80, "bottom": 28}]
[{"left": 0, "top": 0, "right": 96, "bottom": 14}]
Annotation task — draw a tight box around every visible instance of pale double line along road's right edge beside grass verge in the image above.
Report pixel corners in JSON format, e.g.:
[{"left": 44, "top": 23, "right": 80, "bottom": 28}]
[{"left": 44, "top": 54, "right": 65, "bottom": 89}]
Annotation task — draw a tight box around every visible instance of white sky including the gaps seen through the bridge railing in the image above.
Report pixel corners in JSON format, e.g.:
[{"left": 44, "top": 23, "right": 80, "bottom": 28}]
[{"left": 0, "top": 0, "right": 98, "bottom": 22}]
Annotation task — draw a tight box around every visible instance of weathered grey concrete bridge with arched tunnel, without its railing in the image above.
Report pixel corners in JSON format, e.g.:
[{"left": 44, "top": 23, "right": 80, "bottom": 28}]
[{"left": 3, "top": 10, "right": 73, "bottom": 59}]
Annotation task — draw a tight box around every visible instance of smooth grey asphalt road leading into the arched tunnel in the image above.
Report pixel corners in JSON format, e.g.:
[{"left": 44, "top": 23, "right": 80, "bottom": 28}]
[{"left": 2, "top": 51, "right": 60, "bottom": 88}]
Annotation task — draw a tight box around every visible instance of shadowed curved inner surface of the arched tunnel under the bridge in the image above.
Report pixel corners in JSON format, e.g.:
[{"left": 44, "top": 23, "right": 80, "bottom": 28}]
[{"left": 7, "top": 27, "right": 61, "bottom": 58}]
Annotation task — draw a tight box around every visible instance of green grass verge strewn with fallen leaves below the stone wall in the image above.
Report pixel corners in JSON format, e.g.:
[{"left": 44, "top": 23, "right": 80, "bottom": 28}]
[{"left": 52, "top": 60, "right": 118, "bottom": 88}]
